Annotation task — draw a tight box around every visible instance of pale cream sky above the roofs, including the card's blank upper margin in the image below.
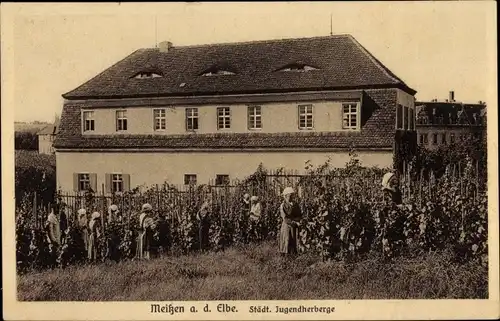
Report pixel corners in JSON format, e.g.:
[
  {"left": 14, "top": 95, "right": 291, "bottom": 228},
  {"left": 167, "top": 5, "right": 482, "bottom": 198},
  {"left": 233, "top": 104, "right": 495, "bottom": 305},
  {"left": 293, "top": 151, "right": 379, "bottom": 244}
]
[{"left": 2, "top": 1, "right": 496, "bottom": 122}]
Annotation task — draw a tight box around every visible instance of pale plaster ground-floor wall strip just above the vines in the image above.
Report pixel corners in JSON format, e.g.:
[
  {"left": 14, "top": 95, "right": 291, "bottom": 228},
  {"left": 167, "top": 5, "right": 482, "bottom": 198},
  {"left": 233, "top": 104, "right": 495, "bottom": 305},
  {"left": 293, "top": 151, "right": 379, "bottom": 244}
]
[{"left": 56, "top": 151, "right": 393, "bottom": 191}]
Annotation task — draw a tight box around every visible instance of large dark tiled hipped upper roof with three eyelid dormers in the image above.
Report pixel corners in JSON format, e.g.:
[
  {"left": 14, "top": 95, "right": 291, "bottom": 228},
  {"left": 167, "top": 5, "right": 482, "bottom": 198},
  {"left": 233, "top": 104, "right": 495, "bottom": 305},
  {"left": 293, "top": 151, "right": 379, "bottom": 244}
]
[{"left": 63, "top": 35, "right": 415, "bottom": 99}]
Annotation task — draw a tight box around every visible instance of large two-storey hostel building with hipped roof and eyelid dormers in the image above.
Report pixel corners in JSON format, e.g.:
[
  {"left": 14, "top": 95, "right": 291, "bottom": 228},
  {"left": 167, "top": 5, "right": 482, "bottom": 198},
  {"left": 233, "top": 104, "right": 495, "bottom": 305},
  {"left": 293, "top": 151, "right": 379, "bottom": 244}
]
[{"left": 55, "top": 35, "right": 415, "bottom": 192}]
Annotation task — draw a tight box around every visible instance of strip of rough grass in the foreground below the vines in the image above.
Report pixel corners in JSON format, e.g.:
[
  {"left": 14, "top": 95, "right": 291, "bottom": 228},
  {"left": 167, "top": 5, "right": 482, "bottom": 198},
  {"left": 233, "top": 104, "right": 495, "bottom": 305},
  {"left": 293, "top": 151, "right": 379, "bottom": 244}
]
[{"left": 17, "top": 242, "right": 488, "bottom": 301}]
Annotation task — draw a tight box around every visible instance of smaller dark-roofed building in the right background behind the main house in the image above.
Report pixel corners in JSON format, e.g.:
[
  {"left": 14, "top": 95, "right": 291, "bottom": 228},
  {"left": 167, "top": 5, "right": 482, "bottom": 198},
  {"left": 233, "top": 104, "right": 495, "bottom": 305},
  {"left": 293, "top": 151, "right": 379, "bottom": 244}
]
[{"left": 415, "top": 91, "right": 486, "bottom": 149}]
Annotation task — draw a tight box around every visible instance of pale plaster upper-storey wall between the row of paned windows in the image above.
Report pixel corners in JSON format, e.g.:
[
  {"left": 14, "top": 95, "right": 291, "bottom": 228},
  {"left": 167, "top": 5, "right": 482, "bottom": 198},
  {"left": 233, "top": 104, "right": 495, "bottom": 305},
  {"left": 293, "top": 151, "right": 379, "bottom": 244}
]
[{"left": 82, "top": 100, "right": 359, "bottom": 135}]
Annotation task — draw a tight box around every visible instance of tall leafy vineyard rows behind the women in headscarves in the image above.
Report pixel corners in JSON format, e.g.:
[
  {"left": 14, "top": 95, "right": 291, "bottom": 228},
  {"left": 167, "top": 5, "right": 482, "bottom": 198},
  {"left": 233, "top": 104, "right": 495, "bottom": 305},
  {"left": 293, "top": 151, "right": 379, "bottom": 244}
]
[{"left": 16, "top": 155, "right": 488, "bottom": 273}]
